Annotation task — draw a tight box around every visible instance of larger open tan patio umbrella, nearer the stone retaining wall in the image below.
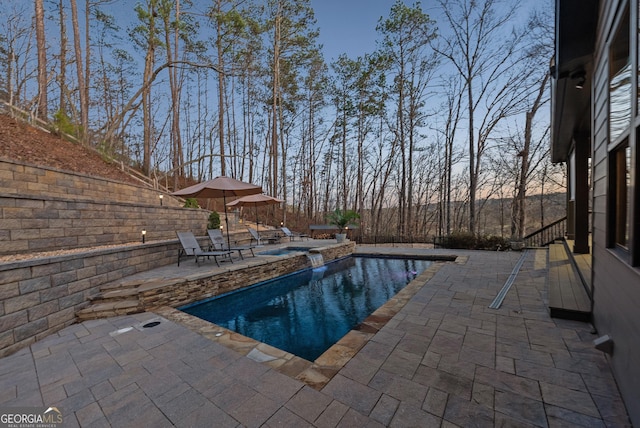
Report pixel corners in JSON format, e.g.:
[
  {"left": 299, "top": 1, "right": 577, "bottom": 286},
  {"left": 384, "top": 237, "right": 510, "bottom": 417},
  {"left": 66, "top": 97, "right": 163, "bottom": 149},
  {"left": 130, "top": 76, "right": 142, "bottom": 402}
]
[{"left": 172, "top": 176, "right": 262, "bottom": 247}]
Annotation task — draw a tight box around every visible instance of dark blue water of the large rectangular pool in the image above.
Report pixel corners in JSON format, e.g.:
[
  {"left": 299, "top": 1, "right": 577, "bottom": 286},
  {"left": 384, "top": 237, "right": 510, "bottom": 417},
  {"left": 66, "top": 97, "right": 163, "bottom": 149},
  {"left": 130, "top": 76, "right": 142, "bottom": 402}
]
[{"left": 180, "top": 257, "right": 431, "bottom": 361}]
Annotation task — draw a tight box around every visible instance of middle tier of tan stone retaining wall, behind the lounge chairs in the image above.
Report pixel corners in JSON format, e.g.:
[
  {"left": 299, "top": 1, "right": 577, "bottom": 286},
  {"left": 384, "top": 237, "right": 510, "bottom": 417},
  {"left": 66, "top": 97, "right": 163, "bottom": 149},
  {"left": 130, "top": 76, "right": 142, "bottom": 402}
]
[{"left": 0, "top": 195, "right": 209, "bottom": 255}]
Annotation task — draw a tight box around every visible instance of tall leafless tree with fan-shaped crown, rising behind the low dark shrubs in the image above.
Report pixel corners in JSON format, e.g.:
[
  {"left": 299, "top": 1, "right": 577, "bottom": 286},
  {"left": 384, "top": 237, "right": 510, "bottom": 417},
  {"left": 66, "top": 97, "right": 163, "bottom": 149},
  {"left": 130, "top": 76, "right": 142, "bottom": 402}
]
[{"left": 436, "top": 0, "right": 523, "bottom": 234}]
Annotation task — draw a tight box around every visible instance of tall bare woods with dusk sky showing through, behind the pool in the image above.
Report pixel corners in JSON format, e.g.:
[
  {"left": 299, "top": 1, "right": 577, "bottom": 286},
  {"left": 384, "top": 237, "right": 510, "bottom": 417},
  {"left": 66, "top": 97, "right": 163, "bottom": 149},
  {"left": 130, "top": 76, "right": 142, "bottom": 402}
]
[{"left": 0, "top": 0, "right": 563, "bottom": 238}]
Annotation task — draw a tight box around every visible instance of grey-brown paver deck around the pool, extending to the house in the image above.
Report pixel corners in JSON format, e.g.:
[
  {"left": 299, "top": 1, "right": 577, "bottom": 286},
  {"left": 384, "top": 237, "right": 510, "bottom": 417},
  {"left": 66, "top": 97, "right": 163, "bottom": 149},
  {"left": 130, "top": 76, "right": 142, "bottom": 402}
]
[{"left": 0, "top": 248, "right": 630, "bottom": 427}]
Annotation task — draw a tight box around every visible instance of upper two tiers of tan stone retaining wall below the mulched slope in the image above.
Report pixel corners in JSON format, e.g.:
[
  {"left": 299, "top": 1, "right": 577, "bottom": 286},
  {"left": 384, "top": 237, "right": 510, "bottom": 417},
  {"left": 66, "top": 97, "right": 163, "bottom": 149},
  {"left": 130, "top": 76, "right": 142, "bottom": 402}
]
[{"left": 0, "top": 160, "right": 214, "bottom": 255}]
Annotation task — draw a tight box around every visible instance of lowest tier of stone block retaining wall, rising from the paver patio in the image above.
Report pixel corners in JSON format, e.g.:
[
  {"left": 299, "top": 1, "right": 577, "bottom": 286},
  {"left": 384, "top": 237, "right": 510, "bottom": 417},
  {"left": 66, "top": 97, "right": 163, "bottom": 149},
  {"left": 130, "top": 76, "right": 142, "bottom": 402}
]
[{"left": 0, "top": 240, "right": 178, "bottom": 357}]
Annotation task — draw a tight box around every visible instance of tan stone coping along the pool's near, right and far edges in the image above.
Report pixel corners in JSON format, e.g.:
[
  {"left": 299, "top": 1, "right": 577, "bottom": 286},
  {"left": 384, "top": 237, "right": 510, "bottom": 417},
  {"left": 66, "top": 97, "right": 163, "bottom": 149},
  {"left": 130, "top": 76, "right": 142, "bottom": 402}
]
[{"left": 158, "top": 251, "right": 469, "bottom": 390}]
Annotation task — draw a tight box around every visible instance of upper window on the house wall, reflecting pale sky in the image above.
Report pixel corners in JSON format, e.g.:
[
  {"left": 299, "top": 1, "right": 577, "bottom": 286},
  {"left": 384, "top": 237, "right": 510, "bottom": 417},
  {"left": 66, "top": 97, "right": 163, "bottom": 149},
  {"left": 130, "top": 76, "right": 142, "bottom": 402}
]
[{"left": 609, "top": 8, "right": 632, "bottom": 142}]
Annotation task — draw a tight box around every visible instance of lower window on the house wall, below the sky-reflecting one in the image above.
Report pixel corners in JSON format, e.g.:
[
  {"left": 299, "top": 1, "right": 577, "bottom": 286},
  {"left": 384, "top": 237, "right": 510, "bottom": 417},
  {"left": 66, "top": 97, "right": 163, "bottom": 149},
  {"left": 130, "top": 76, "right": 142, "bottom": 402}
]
[{"left": 610, "top": 142, "right": 632, "bottom": 250}]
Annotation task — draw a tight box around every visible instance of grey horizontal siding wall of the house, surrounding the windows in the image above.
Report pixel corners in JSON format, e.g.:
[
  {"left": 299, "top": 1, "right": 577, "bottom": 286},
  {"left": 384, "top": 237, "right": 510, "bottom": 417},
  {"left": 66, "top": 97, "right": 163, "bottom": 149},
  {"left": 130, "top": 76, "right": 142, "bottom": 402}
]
[{"left": 592, "top": 0, "right": 640, "bottom": 425}]
